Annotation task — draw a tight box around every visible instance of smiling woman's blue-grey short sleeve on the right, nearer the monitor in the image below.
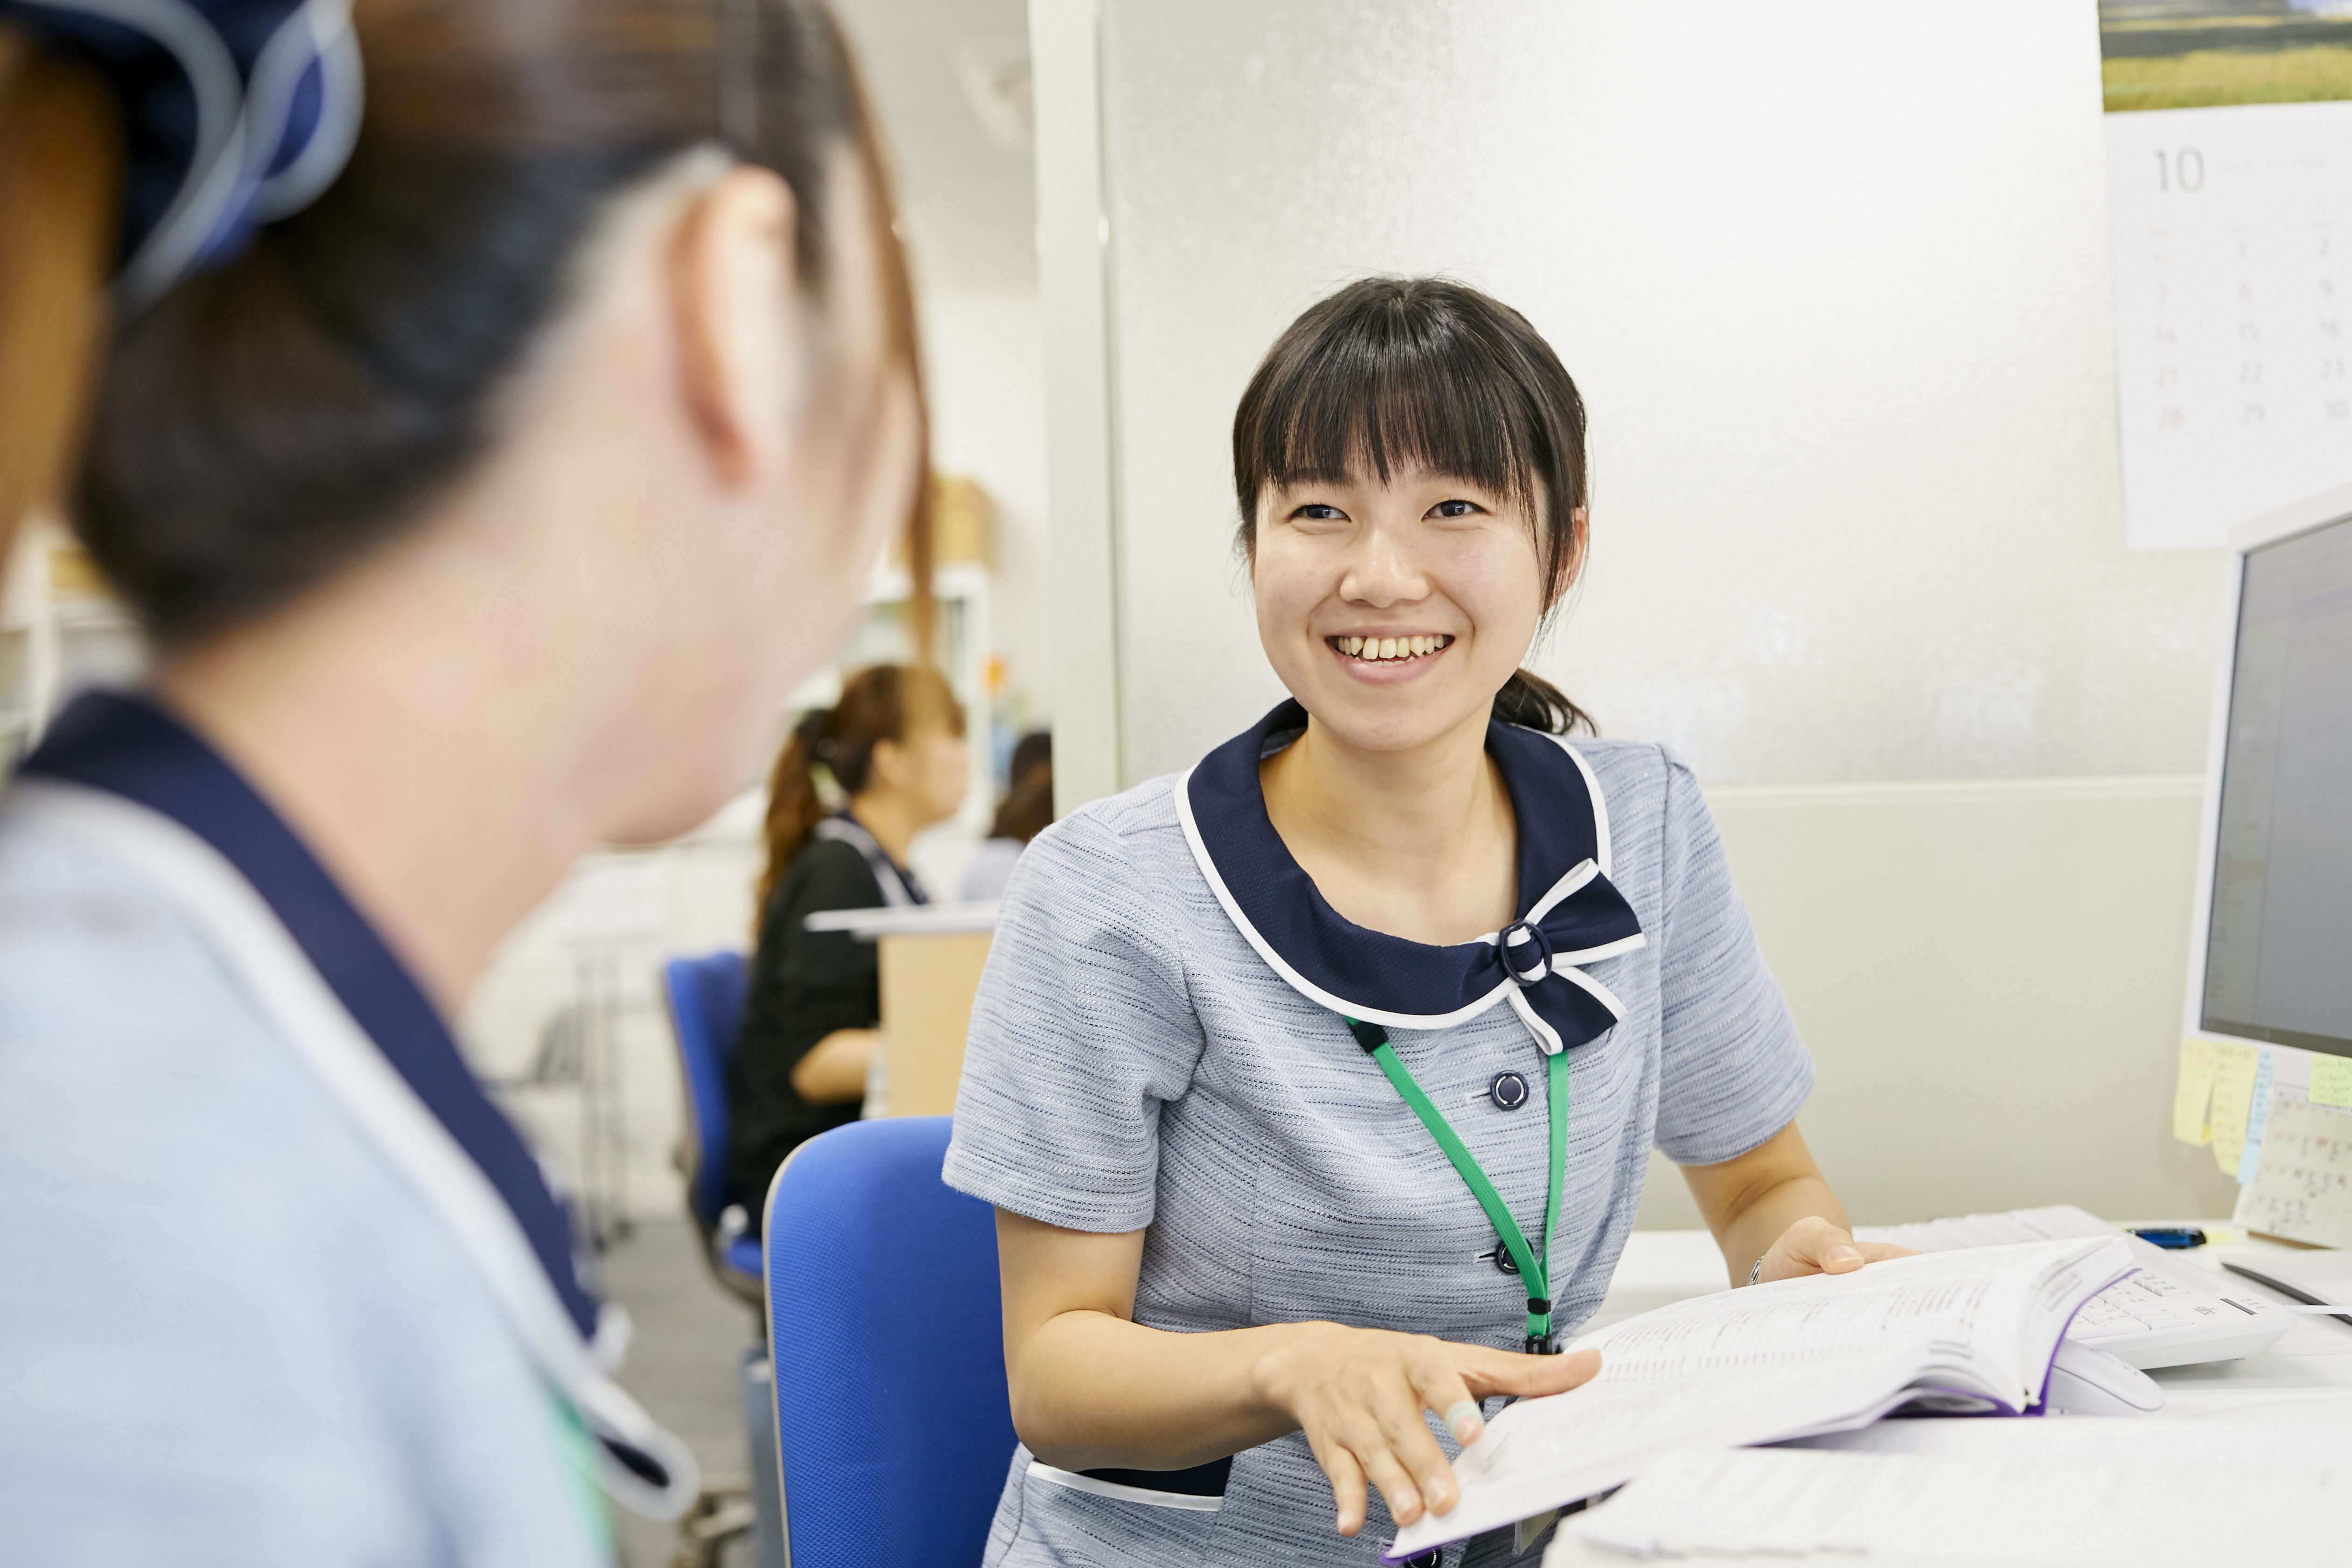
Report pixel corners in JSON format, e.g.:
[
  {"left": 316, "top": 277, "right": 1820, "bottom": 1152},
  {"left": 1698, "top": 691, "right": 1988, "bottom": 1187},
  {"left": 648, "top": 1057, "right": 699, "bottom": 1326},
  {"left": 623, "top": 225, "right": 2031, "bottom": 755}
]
[{"left": 1653, "top": 757, "right": 1813, "bottom": 1166}]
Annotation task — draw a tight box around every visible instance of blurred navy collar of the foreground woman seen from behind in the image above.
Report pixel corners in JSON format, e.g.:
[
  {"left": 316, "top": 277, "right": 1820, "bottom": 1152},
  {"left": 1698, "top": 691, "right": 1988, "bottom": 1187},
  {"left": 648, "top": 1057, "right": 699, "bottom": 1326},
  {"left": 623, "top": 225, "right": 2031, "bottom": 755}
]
[{"left": 21, "top": 693, "right": 597, "bottom": 1337}]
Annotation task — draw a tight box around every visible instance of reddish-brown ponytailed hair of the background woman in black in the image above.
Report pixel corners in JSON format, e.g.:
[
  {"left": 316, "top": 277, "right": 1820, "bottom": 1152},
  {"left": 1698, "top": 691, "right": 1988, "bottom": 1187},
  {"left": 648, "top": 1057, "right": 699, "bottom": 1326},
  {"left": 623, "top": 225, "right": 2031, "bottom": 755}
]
[{"left": 753, "top": 665, "right": 964, "bottom": 926}]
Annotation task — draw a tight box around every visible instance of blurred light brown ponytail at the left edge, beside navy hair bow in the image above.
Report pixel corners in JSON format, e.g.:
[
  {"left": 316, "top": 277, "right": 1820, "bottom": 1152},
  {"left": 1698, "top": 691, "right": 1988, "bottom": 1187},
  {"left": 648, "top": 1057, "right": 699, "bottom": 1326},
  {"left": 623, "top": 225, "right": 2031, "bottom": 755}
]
[{"left": 0, "top": 28, "right": 122, "bottom": 562}]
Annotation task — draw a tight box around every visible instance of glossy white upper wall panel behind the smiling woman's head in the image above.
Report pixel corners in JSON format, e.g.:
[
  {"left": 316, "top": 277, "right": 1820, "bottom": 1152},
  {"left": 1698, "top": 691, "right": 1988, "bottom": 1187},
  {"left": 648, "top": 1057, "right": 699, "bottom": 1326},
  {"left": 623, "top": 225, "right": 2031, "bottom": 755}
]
[{"left": 1082, "top": 0, "right": 2220, "bottom": 783}]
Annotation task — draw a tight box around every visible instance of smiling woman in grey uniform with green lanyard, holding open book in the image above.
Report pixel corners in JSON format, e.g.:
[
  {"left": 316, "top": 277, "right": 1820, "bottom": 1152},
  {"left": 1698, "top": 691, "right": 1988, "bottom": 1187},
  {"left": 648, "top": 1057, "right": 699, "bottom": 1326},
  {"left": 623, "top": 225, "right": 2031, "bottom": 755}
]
[{"left": 945, "top": 280, "right": 1886, "bottom": 1568}]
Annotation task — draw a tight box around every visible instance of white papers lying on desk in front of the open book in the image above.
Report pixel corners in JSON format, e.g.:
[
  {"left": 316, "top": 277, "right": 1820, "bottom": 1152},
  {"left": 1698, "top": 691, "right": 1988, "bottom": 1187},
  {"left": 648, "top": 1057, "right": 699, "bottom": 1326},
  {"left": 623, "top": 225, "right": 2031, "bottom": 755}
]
[{"left": 1550, "top": 1418, "right": 2352, "bottom": 1568}]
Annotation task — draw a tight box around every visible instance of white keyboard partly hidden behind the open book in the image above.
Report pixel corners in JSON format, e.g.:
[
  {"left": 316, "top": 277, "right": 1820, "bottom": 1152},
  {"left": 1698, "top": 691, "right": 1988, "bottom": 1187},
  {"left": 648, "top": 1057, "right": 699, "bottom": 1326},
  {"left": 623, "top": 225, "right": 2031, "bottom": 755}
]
[{"left": 1854, "top": 1204, "right": 2298, "bottom": 1371}]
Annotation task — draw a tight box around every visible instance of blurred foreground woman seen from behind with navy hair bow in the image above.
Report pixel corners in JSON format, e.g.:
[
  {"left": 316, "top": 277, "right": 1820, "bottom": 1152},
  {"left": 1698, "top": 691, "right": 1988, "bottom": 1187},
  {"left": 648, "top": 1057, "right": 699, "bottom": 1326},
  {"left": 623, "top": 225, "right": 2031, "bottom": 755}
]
[{"left": 0, "top": 0, "right": 929, "bottom": 1568}]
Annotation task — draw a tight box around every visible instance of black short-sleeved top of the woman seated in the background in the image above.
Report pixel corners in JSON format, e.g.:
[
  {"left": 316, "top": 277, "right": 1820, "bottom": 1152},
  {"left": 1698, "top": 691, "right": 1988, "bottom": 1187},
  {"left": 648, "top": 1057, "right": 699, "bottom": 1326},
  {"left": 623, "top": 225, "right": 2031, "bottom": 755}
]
[{"left": 727, "top": 839, "right": 884, "bottom": 1230}]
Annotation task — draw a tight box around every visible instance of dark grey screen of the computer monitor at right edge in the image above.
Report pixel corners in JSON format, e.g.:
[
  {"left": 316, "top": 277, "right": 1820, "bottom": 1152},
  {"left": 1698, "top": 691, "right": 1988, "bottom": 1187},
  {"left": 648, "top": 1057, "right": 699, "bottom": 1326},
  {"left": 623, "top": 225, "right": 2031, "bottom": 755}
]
[{"left": 2204, "top": 517, "right": 2352, "bottom": 1056}]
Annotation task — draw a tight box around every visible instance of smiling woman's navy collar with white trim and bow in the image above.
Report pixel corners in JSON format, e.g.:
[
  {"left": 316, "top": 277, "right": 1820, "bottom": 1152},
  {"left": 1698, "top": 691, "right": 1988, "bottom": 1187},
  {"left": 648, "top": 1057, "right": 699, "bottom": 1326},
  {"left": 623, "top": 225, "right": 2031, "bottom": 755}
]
[{"left": 1176, "top": 700, "right": 1644, "bottom": 1051}]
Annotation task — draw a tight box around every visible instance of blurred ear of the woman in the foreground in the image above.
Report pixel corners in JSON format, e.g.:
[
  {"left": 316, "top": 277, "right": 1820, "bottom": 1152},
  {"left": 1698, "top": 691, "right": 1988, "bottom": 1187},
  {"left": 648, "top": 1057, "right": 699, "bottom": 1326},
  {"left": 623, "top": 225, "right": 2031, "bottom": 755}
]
[{"left": 670, "top": 165, "right": 809, "bottom": 489}]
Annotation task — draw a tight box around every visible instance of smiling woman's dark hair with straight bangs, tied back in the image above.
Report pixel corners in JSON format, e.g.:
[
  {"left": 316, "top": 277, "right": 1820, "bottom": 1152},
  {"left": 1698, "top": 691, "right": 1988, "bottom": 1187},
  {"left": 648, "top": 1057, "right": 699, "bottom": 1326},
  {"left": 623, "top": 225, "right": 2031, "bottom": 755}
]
[{"left": 1232, "top": 277, "right": 1595, "bottom": 734}]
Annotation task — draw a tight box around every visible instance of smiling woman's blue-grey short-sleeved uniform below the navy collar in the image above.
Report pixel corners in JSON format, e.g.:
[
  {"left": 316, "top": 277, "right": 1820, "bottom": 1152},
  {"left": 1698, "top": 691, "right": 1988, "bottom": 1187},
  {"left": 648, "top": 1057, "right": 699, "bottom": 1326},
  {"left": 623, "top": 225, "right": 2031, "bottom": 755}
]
[{"left": 945, "top": 710, "right": 1813, "bottom": 1568}]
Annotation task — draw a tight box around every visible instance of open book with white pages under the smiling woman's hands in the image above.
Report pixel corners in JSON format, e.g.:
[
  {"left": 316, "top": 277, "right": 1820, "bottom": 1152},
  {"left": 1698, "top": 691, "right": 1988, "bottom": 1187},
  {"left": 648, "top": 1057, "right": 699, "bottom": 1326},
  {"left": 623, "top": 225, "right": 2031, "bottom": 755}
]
[{"left": 1383, "top": 1237, "right": 2135, "bottom": 1561}]
